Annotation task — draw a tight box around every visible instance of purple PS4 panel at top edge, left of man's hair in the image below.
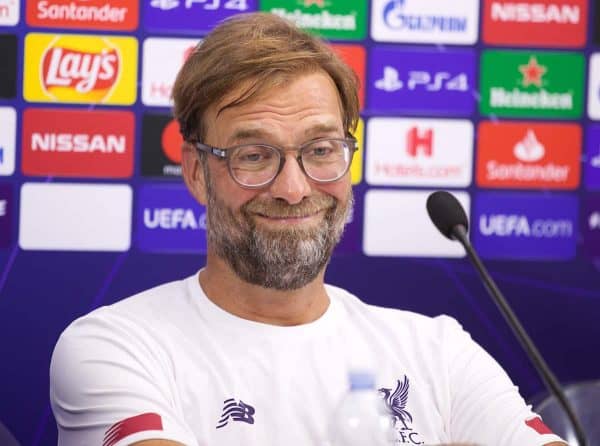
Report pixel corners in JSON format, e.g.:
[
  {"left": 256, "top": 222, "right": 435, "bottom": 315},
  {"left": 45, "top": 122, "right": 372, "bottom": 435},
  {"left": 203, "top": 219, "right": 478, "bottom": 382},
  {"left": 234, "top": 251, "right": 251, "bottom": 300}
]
[{"left": 142, "top": 0, "right": 257, "bottom": 35}]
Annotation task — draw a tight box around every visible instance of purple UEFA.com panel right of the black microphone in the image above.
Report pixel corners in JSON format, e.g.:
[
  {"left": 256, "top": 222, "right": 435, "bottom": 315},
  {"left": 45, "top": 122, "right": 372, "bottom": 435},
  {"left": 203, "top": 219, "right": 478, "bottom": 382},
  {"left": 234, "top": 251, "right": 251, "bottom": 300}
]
[{"left": 470, "top": 192, "right": 579, "bottom": 260}]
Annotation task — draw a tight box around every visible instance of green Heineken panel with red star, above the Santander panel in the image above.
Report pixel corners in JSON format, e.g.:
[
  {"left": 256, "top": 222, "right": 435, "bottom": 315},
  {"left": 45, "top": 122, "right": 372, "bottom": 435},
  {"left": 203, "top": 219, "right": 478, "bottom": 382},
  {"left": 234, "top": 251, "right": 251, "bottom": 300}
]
[{"left": 480, "top": 50, "right": 584, "bottom": 118}]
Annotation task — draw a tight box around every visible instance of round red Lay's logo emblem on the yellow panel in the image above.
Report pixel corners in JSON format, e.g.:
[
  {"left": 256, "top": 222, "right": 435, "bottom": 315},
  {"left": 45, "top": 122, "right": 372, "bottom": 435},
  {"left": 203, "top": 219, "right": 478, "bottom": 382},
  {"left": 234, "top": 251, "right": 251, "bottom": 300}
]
[{"left": 40, "top": 38, "right": 121, "bottom": 100}]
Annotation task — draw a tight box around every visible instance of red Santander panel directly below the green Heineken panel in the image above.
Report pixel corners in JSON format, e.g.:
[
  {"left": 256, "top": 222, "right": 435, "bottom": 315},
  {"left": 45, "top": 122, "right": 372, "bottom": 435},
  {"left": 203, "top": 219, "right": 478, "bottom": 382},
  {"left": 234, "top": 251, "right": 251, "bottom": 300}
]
[{"left": 477, "top": 122, "right": 581, "bottom": 189}]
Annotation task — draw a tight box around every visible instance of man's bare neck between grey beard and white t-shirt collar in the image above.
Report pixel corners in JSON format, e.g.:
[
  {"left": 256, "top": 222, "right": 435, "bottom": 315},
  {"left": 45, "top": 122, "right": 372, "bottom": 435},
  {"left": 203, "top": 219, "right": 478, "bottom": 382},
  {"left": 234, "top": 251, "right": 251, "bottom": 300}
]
[{"left": 199, "top": 254, "right": 329, "bottom": 326}]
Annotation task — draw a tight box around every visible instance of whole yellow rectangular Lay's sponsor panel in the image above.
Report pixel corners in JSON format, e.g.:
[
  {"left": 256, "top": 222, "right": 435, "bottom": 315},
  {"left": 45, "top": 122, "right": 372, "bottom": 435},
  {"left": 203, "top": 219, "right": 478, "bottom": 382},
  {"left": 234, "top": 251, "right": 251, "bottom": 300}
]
[{"left": 23, "top": 33, "right": 137, "bottom": 105}]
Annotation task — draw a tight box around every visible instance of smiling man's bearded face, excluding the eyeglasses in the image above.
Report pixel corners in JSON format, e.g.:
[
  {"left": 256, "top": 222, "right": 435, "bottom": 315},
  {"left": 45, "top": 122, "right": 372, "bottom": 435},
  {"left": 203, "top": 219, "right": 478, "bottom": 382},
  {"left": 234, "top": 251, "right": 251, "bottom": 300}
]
[{"left": 195, "top": 72, "right": 352, "bottom": 290}]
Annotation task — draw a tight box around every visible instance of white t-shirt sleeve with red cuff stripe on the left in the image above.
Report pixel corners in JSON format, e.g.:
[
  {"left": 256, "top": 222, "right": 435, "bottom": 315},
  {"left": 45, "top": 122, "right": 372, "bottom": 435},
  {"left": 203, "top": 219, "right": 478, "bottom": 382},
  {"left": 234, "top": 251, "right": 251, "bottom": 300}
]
[{"left": 50, "top": 309, "right": 197, "bottom": 446}]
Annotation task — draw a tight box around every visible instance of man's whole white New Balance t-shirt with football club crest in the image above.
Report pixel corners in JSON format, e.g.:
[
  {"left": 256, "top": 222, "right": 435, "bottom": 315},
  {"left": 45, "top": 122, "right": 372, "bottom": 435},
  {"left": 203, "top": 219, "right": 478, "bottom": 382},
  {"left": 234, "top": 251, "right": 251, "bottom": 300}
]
[{"left": 50, "top": 275, "right": 560, "bottom": 446}]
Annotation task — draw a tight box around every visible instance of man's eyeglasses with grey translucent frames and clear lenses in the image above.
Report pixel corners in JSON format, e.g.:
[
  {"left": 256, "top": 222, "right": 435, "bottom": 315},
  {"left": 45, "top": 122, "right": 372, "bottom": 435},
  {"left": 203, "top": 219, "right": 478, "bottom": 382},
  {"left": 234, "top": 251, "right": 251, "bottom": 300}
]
[{"left": 192, "top": 138, "right": 358, "bottom": 188}]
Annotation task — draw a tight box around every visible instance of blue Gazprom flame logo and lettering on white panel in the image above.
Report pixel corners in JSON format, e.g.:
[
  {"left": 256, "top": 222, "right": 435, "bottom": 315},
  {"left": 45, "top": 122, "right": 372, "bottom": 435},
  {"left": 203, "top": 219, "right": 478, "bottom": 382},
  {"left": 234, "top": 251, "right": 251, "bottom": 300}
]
[{"left": 383, "top": 0, "right": 467, "bottom": 33}]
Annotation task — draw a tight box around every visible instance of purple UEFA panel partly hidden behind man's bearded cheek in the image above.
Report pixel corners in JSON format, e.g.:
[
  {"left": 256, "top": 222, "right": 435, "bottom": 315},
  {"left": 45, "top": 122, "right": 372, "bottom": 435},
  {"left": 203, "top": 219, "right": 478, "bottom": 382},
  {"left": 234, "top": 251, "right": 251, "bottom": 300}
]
[{"left": 135, "top": 184, "right": 206, "bottom": 253}]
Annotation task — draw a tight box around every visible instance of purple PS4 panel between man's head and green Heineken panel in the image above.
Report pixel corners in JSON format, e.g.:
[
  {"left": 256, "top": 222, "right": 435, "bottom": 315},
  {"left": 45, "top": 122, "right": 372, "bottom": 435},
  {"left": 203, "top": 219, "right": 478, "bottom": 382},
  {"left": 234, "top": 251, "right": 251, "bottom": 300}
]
[{"left": 368, "top": 46, "right": 476, "bottom": 116}]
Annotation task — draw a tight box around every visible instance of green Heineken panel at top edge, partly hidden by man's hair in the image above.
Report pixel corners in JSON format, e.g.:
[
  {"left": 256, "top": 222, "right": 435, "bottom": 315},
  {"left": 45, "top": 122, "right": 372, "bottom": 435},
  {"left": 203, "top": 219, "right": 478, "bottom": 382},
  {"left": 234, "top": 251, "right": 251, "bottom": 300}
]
[{"left": 260, "top": 0, "right": 367, "bottom": 40}]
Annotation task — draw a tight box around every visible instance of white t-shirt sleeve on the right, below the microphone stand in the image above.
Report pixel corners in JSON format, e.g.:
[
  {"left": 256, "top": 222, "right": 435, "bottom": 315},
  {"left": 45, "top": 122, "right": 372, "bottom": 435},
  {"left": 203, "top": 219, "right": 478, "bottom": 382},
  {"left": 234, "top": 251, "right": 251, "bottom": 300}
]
[{"left": 440, "top": 316, "right": 564, "bottom": 446}]
